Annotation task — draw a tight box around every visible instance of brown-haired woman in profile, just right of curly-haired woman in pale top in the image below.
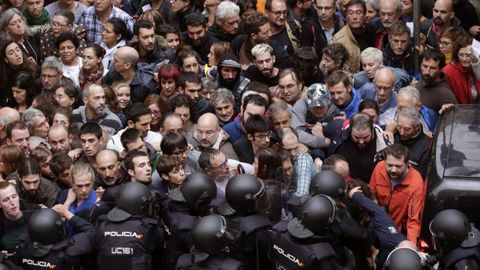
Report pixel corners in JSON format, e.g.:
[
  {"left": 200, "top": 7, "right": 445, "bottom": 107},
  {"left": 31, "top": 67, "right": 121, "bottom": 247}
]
[{"left": 78, "top": 44, "right": 105, "bottom": 89}]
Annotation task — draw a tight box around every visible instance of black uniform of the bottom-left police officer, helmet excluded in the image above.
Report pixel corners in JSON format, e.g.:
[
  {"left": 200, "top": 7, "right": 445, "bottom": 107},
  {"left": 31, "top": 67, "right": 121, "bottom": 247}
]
[{"left": 13, "top": 216, "right": 94, "bottom": 270}]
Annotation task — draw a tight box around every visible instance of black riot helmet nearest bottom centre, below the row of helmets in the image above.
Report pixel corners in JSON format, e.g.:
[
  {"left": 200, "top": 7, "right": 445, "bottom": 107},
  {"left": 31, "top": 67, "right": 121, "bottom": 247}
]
[{"left": 192, "top": 215, "right": 227, "bottom": 255}]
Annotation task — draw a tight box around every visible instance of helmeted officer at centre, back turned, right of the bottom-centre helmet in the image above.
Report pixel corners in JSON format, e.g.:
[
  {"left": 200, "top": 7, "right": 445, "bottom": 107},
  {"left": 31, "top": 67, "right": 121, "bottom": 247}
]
[{"left": 218, "top": 174, "right": 271, "bottom": 269}]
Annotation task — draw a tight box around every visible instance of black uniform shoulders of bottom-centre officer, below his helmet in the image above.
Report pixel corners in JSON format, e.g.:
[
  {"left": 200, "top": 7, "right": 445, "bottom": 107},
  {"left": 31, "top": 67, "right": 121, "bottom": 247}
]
[{"left": 175, "top": 254, "right": 242, "bottom": 270}]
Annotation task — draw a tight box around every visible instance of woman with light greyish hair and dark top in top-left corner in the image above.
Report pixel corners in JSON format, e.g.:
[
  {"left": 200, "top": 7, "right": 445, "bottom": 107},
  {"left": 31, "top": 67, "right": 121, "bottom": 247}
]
[{"left": 0, "top": 8, "right": 41, "bottom": 65}]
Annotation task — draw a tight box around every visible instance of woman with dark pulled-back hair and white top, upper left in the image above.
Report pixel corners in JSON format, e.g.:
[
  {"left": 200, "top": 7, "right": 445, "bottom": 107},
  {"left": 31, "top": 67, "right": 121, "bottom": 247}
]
[{"left": 100, "top": 17, "right": 132, "bottom": 71}]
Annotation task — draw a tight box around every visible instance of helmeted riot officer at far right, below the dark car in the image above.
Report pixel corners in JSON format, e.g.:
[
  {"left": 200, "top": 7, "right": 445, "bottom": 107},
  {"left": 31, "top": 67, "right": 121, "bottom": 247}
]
[{"left": 429, "top": 209, "right": 480, "bottom": 270}]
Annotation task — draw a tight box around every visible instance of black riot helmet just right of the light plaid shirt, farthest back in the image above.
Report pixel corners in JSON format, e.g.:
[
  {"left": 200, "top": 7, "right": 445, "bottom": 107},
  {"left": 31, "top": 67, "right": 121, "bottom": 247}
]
[{"left": 310, "top": 170, "right": 346, "bottom": 200}]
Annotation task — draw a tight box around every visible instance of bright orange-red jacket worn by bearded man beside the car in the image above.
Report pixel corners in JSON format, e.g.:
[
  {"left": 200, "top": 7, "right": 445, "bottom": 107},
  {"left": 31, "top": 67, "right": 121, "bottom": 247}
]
[{"left": 369, "top": 161, "right": 424, "bottom": 244}]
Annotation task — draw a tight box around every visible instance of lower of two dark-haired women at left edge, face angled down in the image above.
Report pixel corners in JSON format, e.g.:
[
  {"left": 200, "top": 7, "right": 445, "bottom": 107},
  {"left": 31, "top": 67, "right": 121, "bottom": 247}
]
[{"left": 12, "top": 71, "right": 36, "bottom": 113}]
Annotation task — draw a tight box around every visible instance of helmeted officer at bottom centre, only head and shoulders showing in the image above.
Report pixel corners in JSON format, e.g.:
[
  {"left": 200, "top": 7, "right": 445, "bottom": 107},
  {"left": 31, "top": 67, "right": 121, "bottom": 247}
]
[{"left": 175, "top": 215, "right": 243, "bottom": 270}]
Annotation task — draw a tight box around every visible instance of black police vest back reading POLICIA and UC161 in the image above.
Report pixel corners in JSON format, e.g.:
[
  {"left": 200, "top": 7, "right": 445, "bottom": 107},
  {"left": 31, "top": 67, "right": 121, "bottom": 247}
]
[{"left": 95, "top": 218, "right": 158, "bottom": 270}]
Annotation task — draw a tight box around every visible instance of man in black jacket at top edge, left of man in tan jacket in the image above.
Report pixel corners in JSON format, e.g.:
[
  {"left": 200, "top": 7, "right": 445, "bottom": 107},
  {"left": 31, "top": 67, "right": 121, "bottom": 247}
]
[{"left": 300, "top": 0, "right": 345, "bottom": 57}]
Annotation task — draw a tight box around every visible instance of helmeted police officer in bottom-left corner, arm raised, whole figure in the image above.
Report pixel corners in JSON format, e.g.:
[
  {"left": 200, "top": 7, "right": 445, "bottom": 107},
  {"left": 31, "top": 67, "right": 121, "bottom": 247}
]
[{"left": 14, "top": 208, "right": 94, "bottom": 269}]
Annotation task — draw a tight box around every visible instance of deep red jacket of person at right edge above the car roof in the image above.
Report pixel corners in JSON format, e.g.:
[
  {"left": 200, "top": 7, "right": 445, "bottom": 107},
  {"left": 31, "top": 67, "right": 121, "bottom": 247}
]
[{"left": 443, "top": 60, "right": 480, "bottom": 104}]
